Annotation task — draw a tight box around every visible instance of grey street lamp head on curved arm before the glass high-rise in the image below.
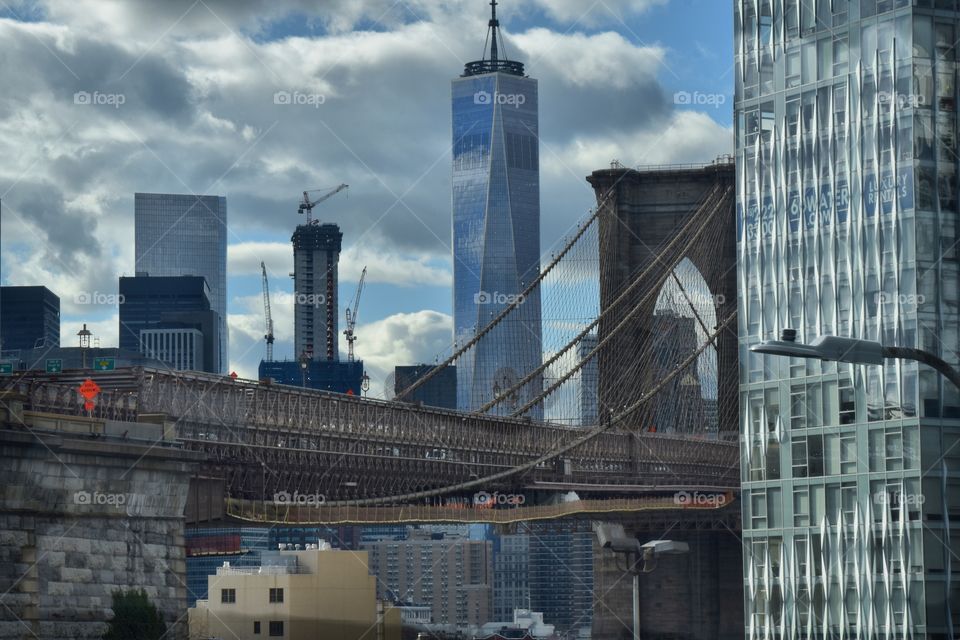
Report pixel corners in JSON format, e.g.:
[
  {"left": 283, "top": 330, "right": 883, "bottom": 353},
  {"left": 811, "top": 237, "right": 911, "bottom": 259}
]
[{"left": 750, "top": 329, "right": 960, "bottom": 389}]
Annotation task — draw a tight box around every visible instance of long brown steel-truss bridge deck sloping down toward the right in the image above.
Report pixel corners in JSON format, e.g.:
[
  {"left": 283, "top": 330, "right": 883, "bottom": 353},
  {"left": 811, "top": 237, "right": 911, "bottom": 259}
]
[{"left": 0, "top": 367, "right": 739, "bottom": 505}]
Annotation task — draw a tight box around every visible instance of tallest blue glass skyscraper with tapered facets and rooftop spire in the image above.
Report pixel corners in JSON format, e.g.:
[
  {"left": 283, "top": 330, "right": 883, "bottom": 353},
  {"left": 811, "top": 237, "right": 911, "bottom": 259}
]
[{"left": 452, "top": 3, "right": 542, "bottom": 419}]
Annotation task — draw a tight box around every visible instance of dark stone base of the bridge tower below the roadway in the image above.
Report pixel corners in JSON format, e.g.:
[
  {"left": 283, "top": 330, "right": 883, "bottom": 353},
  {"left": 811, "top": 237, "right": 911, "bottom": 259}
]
[{"left": 593, "top": 529, "right": 744, "bottom": 640}]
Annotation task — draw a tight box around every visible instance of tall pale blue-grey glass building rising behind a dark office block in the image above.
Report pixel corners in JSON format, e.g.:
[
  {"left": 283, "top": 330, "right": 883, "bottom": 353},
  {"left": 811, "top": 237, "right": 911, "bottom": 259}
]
[{"left": 134, "top": 193, "right": 229, "bottom": 373}]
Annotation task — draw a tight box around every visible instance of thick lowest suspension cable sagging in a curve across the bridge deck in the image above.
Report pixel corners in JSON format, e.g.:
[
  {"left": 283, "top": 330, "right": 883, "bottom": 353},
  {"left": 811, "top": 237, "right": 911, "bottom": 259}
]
[{"left": 325, "top": 312, "right": 737, "bottom": 507}]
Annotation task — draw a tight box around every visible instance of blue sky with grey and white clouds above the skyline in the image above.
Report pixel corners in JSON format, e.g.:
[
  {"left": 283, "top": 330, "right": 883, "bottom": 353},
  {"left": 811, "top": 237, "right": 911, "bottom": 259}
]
[{"left": 0, "top": 0, "right": 733, "bottom": 388}]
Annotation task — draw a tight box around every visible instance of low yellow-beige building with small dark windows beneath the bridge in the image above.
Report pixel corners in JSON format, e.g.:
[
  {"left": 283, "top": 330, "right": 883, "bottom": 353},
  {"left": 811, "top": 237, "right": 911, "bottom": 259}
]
[{"left": 188, "top": 542, "right": 401, "bottom": 640}]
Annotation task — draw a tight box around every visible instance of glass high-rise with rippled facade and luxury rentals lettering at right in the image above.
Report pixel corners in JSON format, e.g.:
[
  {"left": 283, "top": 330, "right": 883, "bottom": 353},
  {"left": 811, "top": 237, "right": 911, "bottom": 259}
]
[{"left": 735, "top": 0, "right": 960, "bottom": 638}]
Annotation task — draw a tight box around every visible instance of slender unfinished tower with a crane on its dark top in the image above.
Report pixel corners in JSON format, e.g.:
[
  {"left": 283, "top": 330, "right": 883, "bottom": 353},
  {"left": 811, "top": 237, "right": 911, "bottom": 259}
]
[{"left": 291, "top": 220, "right": 343, "bottom": 362}]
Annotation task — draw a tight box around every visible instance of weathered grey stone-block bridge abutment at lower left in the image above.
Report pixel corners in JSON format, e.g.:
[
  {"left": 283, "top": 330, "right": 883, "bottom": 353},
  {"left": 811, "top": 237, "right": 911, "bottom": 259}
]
[{"left": 0, "top": 415, "right": 196, "bottom": 640}]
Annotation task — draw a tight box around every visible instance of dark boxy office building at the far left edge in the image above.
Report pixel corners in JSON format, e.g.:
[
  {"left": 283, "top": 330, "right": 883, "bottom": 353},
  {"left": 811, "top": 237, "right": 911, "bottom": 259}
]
[{"left": 0, "top": 287, "right": 60, "bottom": 352}]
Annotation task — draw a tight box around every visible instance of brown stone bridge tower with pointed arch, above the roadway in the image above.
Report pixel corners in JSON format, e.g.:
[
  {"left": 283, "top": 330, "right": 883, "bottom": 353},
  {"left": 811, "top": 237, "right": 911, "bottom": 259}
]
[{"left": 587, "top": 161, "right": 739, "bottom": 438}]
